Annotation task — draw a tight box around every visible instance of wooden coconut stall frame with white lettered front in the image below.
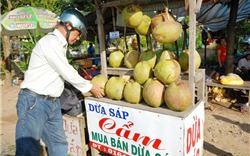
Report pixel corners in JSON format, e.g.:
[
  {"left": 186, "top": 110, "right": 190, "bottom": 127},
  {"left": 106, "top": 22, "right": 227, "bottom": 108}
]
[{"left": 62, "top": 0, "right": 205, "bottom": 156}]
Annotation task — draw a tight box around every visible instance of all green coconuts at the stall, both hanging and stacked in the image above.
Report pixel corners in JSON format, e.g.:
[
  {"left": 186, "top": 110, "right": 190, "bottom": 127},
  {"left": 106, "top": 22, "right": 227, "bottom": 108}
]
[{"left": 94, "top": 5, "right": 201, "bottom": 112}]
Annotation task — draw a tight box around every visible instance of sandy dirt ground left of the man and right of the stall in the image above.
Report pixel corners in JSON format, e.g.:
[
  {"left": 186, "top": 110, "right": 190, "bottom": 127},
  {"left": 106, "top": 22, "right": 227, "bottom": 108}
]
[{"left": 0, "top": 83, "right": 250, "bottom": 156}]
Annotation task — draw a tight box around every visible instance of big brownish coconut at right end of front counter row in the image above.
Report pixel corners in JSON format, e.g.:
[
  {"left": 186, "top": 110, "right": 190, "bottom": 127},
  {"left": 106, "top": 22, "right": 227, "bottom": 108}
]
[{"left": 164, "top": 81, "right": 192, "bottom": 112}]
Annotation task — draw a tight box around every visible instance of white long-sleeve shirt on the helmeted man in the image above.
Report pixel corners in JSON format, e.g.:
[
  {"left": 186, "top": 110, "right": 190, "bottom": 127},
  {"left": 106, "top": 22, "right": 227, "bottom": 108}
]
[{"left": 21, "top": 29, "right": 92, "bottom": 97}]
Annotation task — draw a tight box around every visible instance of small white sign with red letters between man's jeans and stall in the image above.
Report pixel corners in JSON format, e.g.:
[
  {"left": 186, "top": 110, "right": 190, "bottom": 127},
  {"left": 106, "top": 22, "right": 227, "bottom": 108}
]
[{"left": 63, "top": 115, "right": 85, "bottom": 156}]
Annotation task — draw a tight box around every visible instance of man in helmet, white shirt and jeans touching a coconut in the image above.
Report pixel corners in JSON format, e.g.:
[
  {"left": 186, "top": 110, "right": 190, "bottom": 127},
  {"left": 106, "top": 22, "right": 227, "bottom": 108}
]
[{"left": 16, "top": 9, "right": 104, "bottom": 156}]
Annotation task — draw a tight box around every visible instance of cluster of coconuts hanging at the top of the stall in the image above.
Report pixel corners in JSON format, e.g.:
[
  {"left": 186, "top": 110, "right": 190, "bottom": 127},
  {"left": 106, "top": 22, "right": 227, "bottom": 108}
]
[{"left": 122, "top": 5, "right": 182, "bottom": 44}]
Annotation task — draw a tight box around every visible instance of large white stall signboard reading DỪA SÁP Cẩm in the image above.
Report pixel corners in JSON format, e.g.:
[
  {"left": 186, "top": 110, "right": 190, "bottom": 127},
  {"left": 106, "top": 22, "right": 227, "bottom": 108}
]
[{"left": 85, "top": 98, "right": 204, "bottom": 156}]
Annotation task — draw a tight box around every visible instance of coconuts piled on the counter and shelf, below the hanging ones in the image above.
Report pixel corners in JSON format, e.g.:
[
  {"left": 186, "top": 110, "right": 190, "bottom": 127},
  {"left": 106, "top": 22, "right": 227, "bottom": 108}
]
[{"left": 92, "top": 47, "right": 196, "bottom": 112}]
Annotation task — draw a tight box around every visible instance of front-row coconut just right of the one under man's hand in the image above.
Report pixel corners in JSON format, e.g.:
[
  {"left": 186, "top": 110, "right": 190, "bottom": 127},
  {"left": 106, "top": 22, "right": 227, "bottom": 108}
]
[{"left": 105, "top": 76, "right": 126, "bottom": 100}]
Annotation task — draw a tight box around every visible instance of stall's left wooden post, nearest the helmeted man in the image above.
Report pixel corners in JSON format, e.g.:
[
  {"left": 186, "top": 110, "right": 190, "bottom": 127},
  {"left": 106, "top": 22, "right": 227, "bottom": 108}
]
[{"left": 95, "top": 0, "right": 108, "bottom": 77}]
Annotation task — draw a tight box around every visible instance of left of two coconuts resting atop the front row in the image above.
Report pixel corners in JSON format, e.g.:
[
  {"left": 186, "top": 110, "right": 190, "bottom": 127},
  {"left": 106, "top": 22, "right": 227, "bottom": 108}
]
[{"left": 133, "top": 61, "right": 152, "bottom": 84}]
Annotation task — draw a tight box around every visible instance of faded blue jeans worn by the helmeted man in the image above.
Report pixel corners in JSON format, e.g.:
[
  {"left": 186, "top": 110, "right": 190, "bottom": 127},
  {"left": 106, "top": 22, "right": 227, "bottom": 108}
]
[{"left": 16, "top": 89, "right": 68, "bottom": 156}]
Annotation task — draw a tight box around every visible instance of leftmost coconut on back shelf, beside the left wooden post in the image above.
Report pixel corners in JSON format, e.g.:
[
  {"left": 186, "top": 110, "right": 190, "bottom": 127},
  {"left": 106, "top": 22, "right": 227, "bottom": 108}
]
[{"left": 109, "top": 50, "right": 124, "bottom": 68}]
